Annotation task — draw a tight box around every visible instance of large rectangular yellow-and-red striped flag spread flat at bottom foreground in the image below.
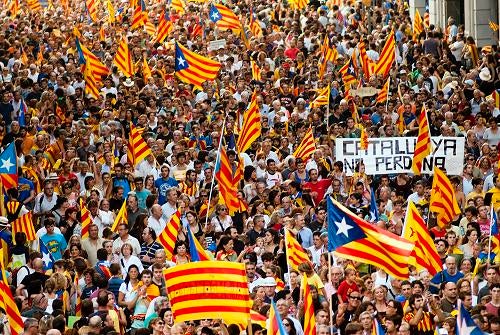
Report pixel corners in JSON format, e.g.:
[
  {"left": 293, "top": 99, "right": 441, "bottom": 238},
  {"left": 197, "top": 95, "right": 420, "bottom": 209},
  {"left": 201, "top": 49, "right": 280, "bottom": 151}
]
[{"left": 165, "top": 261, "right": 252, "bottom": 325}]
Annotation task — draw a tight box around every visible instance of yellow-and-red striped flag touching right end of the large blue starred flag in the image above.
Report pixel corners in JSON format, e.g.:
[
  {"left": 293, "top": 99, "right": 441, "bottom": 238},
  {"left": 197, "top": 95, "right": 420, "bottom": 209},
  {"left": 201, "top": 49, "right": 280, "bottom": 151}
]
[{"left": 402, "top": 201, "right": 443, "bottom": 276}]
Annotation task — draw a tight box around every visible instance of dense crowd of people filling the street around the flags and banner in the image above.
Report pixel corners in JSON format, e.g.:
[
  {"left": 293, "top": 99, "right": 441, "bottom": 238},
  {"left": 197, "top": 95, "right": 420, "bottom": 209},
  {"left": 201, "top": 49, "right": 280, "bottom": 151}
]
[{"left": 0, "top": 0, "right": 500, "bottom": 335}]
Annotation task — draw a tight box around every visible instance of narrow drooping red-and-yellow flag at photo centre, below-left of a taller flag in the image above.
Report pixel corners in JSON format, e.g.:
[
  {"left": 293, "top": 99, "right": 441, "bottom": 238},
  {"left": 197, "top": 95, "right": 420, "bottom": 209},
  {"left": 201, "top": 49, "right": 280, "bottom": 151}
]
[{"left": 215, "top": 147, "right": 240, "bottom": 215}]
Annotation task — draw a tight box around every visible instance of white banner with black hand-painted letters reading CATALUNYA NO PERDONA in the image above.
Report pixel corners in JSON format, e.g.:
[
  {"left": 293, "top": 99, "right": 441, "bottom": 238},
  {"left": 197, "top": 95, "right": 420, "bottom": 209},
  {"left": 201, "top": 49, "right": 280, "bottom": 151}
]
[{"left": 335, "top": 137, "right": 465, "bottom": 176}]
